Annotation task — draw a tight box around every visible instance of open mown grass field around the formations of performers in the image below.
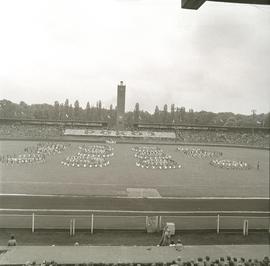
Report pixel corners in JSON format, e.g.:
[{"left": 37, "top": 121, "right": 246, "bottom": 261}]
[{"left": 0, "top": 141, "right": 269, "bottom": 197}]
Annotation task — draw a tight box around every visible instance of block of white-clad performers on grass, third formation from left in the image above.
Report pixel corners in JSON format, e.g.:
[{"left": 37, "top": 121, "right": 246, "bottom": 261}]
[{"left": 132, "top": 146, "right": 181, "bottom": 170}]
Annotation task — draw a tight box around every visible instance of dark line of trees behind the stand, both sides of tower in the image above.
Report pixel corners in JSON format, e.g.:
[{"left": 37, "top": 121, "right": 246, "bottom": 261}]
[{"left": 0, "top": 99, "right": 270, "bottom": 127}]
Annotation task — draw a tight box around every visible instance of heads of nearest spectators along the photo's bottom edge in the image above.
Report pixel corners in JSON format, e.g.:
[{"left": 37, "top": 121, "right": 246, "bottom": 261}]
[{"left": 23, "top": 256, "right": 270, "bottom": 266}]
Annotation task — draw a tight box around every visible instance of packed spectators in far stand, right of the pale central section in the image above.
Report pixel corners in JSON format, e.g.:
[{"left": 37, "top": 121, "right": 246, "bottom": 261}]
[{"left": 176, "top": 130, "right": 270, "bottom": 147}]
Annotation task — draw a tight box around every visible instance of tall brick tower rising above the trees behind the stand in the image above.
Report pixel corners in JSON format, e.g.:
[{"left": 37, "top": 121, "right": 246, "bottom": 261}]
[{"left": 116, "top": 81, "right": 126, "bottom": 130}]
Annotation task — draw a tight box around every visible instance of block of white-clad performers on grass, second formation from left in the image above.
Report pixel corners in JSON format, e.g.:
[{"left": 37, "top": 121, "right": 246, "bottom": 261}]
[{"left": 61, "top": 145, "right": 114, "bottom": 168}]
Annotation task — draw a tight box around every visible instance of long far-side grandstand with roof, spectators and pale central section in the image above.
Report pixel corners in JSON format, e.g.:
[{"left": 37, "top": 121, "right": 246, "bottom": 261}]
[{"left": 0, "top": 118, "right": 270, "bottom": 148}]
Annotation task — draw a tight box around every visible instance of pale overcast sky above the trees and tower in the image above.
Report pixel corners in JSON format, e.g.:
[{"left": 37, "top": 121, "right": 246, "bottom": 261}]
[{"left": 0, "top": 0, "right": 270, "bottom": 114}]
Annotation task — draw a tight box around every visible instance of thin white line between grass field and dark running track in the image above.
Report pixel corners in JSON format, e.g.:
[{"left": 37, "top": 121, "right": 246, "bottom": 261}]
[{"left": 0, "top": 193, "right": 270, "bottom": 200}]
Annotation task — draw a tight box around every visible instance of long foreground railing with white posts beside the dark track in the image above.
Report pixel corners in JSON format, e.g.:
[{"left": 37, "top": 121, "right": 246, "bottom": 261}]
[{"left": 0, "top": 209, "right": 270, "bottom": 235}]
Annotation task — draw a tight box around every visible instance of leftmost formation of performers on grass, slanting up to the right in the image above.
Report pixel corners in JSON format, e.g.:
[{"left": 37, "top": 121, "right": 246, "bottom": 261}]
[{"left": 0, "top": 142, "right": 66, "bottom": 165}]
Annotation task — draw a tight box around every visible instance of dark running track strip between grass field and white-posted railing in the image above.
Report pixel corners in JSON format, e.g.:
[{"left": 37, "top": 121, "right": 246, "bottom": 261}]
[{"left": 0, "top": 195, "right": 269, "bottom": 216}]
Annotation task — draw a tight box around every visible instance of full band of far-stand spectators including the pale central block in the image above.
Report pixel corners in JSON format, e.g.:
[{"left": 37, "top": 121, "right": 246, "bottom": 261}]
[{"left": 0, "top": 124, "right": 270, "bottom": 147}]
